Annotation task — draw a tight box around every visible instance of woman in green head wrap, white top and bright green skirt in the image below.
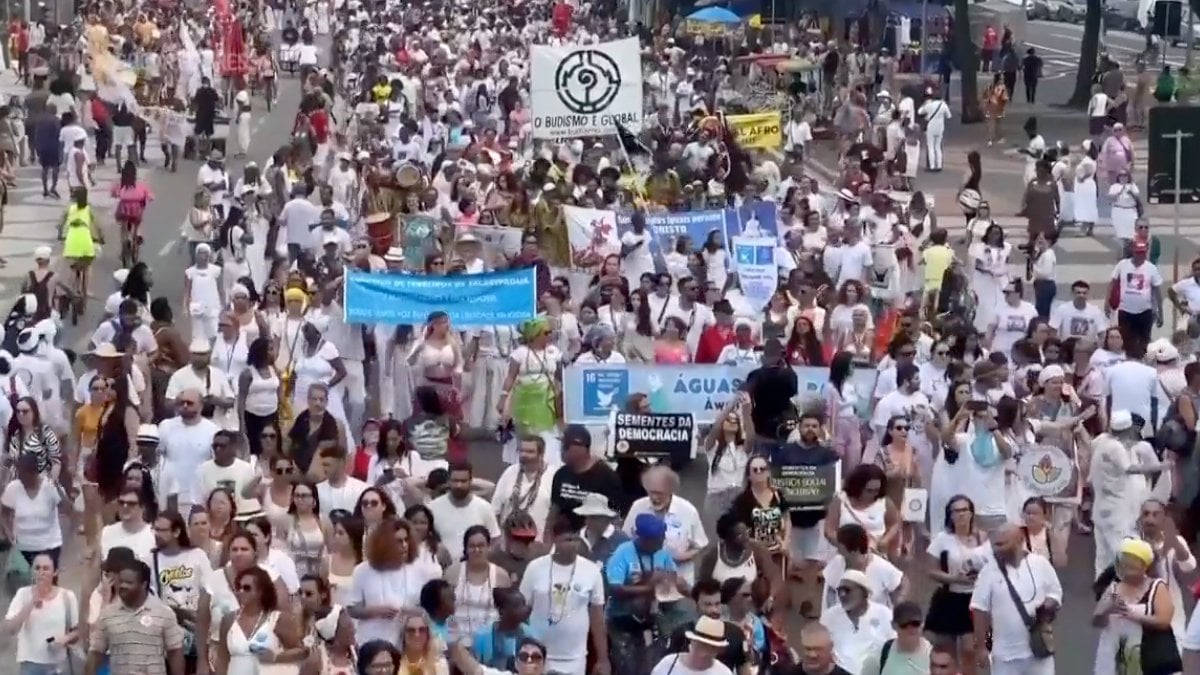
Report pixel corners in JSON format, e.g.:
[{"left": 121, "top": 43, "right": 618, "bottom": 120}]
[{"left": 497, "top": 317, "right": 563, "bottom": 464}]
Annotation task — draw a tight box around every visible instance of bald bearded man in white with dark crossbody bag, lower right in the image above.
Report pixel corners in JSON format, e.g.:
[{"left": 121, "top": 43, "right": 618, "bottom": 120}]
[{"left": 971, "top": 524, "right": 1062, "bottom": 675}]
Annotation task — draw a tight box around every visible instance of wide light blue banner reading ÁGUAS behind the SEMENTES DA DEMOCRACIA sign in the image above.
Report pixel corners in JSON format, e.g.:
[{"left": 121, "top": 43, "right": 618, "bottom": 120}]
[{"left": 563, "top": 364, "right": 877, "bottom": 424}]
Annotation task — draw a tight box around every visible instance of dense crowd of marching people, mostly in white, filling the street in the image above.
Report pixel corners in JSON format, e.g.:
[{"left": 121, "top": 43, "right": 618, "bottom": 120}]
[{"left": 0, "top": 0, "right": 1200, "bottom": 675}]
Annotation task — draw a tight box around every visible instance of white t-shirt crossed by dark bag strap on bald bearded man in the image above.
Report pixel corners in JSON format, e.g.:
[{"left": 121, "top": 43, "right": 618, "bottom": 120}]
[{"left": 971, "top": 554, "right": 1062, "bottom": 661}]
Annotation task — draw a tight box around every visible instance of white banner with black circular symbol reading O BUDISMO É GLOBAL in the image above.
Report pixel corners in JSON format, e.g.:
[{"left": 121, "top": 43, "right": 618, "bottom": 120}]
[{"left": 530, "top": 37, "right": 643, "bottom": 141}]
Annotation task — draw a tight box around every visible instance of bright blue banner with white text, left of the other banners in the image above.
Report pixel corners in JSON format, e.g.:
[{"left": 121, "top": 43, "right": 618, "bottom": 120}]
[{"left": 346, "top": 268, "right": 538, "bottom": 328}]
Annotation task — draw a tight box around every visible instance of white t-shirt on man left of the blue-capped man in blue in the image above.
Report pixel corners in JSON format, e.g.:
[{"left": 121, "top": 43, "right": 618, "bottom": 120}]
[{"left": 521, "top": 555, "right": 605, "bottom": 675}]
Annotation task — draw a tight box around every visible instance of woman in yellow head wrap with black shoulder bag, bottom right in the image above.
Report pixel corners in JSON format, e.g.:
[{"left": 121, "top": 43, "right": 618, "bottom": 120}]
[{"left": 1092, "top": 537, "right": 1183, "bottom": 675}]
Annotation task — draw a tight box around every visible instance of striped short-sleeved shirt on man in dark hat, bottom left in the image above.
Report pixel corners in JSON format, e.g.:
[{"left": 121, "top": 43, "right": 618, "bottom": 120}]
[{"left": 89, "top": 596, "right": 184, "bottom": 675}]
